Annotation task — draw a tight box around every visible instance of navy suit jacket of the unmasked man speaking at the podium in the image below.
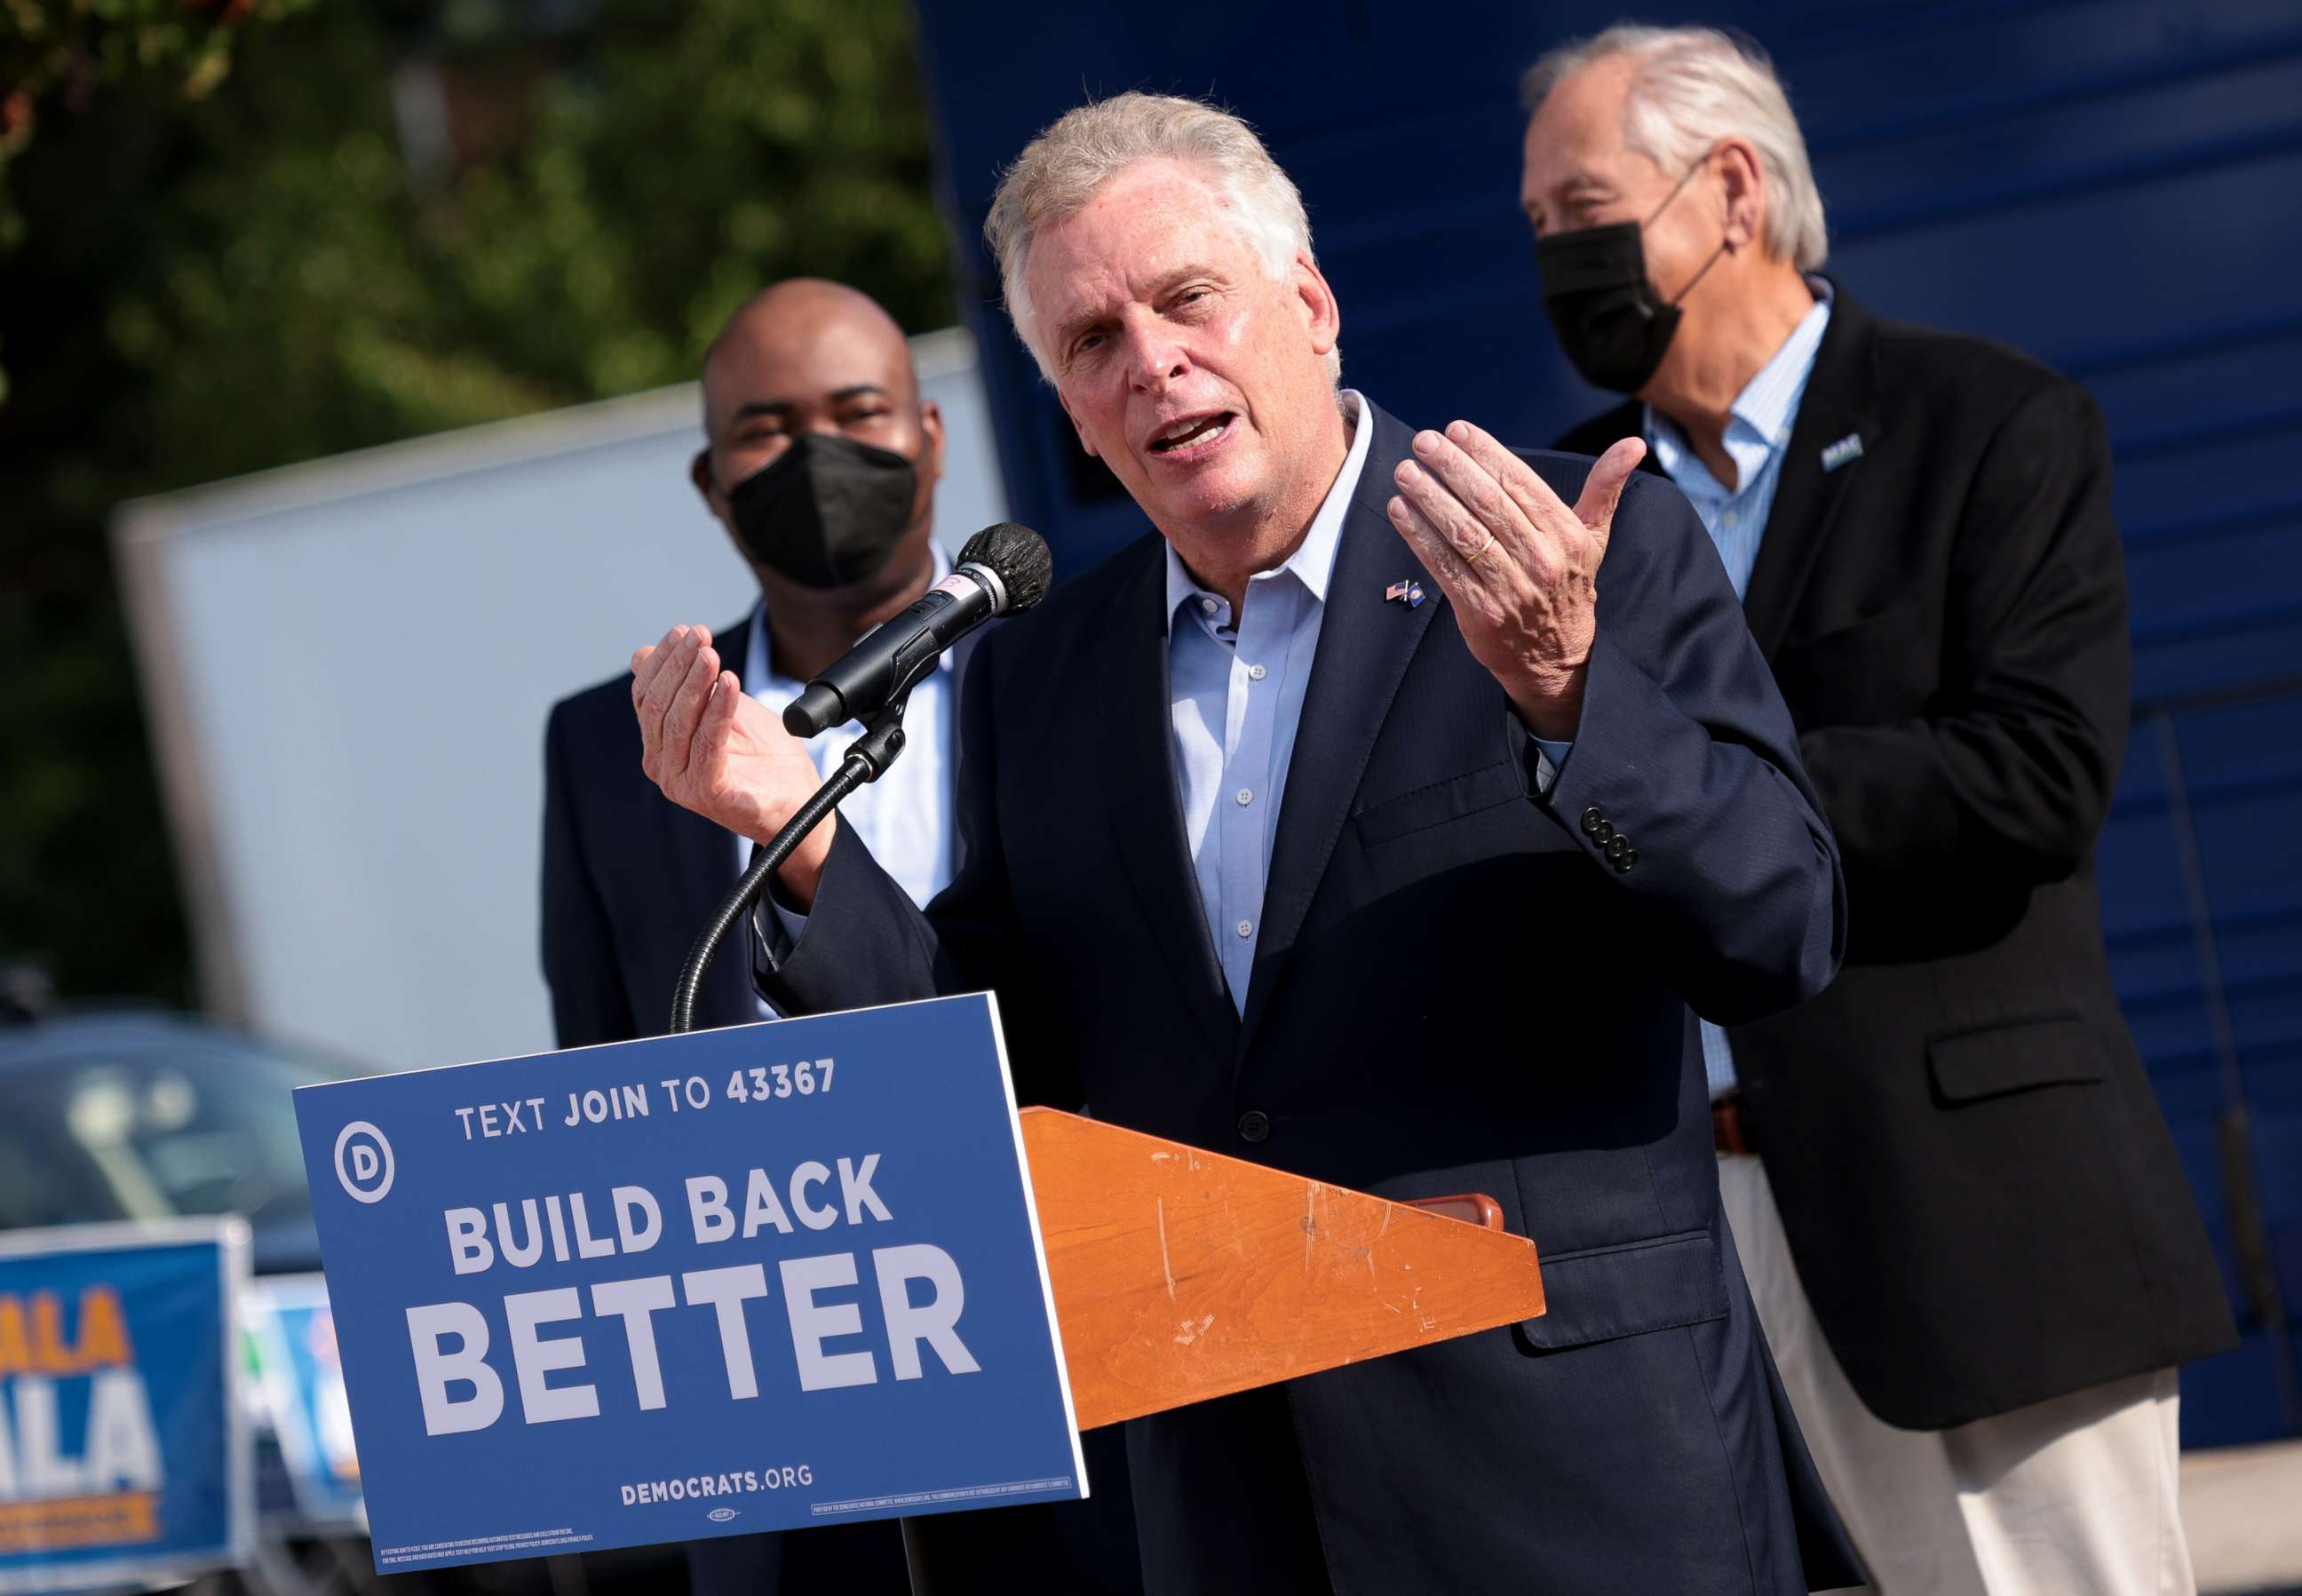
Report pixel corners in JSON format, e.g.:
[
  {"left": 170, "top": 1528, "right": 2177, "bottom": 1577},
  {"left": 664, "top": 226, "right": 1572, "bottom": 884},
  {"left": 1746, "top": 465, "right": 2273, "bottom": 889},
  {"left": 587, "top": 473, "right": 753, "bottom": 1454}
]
[{"left": 755, "top": 401, "right": 1854, "bottom": 1596}]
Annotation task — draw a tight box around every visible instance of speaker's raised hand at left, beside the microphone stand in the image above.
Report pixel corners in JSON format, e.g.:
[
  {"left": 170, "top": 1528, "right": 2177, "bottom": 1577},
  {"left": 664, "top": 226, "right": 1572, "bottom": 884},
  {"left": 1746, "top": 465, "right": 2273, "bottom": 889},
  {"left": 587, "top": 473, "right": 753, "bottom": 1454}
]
[{"left": 631, "top": 626, "right": 837, "bottom": 908}]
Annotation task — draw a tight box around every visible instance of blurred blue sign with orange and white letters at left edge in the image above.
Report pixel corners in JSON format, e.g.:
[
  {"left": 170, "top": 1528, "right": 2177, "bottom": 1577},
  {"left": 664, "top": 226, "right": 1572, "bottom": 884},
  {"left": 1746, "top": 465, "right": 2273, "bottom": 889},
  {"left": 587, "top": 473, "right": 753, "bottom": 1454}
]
[{"left": 0, "top": 1219, "right": 249, "bottom": 1592}]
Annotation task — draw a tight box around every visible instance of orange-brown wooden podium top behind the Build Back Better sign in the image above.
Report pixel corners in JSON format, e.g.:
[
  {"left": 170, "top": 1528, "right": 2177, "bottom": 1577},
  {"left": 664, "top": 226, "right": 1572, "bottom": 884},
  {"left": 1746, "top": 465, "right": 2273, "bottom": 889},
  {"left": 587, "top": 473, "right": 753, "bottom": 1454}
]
[{"left": 1022, "top": 1108, "right": 1543, "bottom": 1430}]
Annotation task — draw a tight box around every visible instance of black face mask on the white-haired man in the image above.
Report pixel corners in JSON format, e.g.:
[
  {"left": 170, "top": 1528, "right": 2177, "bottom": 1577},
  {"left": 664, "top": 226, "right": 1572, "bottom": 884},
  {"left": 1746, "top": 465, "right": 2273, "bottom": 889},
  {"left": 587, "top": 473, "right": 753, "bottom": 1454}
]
[{"left": 1536, "top": 163, "right": 1726, "bottom": 393}]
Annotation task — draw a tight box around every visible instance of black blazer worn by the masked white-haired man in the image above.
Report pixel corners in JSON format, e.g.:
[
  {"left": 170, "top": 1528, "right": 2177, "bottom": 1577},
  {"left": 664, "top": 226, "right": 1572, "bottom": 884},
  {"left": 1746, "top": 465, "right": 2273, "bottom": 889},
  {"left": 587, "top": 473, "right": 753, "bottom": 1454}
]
[{"left": 1563, "top": 280, "right": 2235, "bottom": 1428}]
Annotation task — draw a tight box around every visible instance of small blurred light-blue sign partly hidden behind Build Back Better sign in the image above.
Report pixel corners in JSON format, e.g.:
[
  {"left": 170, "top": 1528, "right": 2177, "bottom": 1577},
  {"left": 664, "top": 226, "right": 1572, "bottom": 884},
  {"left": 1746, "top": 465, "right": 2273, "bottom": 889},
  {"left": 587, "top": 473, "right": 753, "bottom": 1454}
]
[{"left": 240, "top": 1274, "right": 369, "bottom": 1534}]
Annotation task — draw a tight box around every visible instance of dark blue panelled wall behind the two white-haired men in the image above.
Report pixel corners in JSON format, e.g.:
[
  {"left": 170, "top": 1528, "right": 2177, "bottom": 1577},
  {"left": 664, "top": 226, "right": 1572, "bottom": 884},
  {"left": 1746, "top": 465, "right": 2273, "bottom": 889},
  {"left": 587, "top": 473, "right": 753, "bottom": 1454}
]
[{"left": 921, "top": 0, "right": 2302, "bottom": 1444}]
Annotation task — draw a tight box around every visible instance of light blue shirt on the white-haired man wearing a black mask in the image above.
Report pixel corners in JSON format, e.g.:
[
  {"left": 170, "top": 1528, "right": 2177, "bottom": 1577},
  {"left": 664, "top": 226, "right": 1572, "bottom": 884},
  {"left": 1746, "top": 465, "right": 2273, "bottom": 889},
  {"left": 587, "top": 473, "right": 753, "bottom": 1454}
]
[{"left": 1646, "top": 276, "right": 1830, "bottom": 1099}]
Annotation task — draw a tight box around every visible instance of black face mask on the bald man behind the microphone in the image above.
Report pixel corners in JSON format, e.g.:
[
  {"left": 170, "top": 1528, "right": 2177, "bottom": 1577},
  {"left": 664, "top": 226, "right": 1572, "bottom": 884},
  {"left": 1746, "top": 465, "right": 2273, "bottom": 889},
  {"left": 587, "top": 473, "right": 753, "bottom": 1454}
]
[{"left": 727, "top": 433, "right": 918, "bottom": 587}]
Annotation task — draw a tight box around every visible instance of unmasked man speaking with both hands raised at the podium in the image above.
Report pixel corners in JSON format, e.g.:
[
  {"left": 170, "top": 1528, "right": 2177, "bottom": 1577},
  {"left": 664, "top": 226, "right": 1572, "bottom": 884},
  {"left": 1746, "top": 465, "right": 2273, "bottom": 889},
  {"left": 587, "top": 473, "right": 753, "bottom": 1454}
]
[{"left": 633, "top": 94, "right": 1854, "bottom": 1596}]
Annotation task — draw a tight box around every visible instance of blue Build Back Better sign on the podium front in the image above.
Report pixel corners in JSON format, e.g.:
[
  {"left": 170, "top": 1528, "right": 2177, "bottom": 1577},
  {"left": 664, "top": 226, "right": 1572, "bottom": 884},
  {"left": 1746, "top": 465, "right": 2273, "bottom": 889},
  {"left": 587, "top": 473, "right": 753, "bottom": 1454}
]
[{"left": 295, "top": 995, "right": 1086, "bottom": 1573}]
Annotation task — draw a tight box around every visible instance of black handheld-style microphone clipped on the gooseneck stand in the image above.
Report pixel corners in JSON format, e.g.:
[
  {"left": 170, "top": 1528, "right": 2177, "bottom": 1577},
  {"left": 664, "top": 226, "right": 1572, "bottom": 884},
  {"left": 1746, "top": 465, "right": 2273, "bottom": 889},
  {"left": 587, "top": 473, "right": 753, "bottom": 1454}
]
[{"left": 782, "top": 520, "right": 1054, "bottom": 737}]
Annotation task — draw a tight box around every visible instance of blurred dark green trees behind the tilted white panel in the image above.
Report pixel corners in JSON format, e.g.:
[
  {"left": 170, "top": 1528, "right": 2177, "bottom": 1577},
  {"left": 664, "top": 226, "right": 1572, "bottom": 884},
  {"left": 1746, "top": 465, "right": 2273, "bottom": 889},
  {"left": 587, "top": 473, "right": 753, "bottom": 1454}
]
[{"left": 0, "top": 0, "right": 950, "bottom": 999}]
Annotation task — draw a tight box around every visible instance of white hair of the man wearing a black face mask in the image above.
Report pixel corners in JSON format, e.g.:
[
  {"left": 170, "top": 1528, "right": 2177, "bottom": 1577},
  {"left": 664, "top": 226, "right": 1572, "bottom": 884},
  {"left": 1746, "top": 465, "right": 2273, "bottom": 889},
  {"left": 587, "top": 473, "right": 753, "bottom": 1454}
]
[{"left": 1520, "top": 23, "right": 1830, "bottom": 272}]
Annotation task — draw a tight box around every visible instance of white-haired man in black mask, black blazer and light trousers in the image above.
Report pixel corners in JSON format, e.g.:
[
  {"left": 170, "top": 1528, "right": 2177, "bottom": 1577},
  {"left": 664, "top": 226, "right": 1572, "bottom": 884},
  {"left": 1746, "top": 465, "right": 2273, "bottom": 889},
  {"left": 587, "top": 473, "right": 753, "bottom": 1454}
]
[{"left": 1521, "top": 26, "right": 2233, "bottom": 1596}]
